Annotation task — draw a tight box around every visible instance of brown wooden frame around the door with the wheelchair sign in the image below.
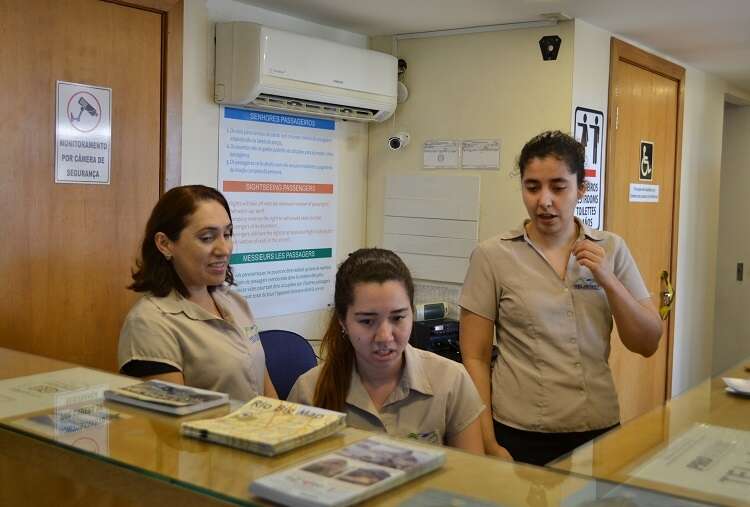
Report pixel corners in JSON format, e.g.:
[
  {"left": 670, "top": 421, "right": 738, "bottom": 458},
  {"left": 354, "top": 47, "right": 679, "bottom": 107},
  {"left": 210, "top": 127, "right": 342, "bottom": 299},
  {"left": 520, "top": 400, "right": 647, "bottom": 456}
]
[{"left": 605, "top": 37, "right": 685, "bottom": 399}]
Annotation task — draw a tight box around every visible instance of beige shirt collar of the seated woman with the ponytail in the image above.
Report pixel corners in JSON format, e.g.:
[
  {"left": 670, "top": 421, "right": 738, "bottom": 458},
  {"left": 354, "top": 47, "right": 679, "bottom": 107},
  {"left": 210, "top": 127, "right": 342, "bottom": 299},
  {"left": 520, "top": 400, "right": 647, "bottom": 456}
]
[{"left": 346, "top": 344, "right": 433, "bottom": 414}]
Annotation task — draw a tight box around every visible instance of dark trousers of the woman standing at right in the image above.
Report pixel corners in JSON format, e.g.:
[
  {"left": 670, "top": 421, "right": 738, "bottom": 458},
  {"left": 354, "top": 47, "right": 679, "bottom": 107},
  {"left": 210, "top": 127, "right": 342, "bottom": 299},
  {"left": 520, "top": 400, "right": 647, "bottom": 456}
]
[{"left": 494, "top": 421, "right": 619, "bottom": 466}]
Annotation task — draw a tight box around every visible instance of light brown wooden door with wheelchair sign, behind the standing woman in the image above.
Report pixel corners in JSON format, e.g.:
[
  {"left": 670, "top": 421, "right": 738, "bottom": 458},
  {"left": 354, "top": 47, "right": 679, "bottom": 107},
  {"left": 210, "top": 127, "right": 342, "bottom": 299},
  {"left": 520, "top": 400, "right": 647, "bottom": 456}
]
[{"left": 604, "top": 39, "right": 684, "bottom": 422}]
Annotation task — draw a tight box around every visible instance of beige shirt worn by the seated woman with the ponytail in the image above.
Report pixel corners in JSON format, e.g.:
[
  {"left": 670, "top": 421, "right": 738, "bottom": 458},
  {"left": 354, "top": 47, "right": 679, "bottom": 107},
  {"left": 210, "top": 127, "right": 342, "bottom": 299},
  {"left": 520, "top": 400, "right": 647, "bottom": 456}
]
[{"left": 288, "top": 345, "right": 484, "bottom": 444}]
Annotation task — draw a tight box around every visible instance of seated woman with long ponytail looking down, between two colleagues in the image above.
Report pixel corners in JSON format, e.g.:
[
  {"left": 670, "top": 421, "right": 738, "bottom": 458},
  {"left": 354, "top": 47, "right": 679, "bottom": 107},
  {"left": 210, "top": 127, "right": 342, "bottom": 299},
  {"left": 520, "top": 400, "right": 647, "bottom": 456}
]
[{"left": 288, "top": 248, "right": 484, "bottom": 454}]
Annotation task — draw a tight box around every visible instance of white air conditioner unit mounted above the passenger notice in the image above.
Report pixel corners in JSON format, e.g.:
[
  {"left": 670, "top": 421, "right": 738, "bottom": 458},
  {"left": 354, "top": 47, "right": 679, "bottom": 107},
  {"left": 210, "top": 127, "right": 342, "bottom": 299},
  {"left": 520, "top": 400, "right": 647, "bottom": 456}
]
[{"left": 214, "top": 22, "right": 397, "bottom": 121}]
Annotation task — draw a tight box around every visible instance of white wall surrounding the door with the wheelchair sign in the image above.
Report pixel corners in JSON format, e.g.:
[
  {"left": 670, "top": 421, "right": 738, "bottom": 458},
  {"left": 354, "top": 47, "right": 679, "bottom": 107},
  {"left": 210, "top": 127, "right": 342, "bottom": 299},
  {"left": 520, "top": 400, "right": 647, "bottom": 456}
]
[{"left": 573, "top": 21, "right": 744, "bottom": 396}]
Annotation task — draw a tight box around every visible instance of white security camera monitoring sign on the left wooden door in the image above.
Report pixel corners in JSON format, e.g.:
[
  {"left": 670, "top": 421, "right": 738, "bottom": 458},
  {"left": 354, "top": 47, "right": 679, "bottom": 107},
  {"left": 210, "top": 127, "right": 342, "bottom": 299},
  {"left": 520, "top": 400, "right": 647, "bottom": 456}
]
[{"left": 55, "top": 81, "right": 112, "bottom": 185}]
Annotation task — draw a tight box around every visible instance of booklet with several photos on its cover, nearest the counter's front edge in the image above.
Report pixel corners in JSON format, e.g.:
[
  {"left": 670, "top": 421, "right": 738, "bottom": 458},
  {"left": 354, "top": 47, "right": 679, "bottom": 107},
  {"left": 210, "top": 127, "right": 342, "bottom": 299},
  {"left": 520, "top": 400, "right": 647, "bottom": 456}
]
[{"left": 250, "top": 436, "right": 445, "bottom": 507}]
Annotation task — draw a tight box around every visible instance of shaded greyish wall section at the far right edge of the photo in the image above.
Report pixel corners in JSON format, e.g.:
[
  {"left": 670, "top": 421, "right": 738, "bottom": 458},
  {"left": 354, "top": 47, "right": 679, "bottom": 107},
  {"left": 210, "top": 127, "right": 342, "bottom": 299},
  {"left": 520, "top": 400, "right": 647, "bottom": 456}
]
[{"left": 712, "top": 104, "right": 750, "bottom": 374}]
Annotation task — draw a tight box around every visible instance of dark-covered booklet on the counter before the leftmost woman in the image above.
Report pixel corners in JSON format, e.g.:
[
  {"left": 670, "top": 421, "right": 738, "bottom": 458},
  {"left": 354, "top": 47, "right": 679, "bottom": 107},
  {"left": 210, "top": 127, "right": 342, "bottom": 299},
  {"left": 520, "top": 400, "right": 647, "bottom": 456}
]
[{"left": 104, "top": 380, "right": 229, "bottom": 415}]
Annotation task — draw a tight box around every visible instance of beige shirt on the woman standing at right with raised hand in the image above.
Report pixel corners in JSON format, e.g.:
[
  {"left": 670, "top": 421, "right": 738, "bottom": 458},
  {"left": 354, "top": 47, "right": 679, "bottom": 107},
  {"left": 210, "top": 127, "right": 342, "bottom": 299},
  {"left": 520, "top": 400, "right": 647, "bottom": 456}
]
[{"left": 459, "top": 219, "right": 649, "bottom": 432}]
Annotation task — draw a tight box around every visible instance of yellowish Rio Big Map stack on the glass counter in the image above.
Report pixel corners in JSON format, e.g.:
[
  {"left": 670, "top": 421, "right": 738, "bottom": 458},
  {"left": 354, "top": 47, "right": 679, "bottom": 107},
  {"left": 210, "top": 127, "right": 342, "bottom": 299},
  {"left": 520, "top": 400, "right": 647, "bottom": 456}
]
[{"left": 180, "top": 396, "right": 346, "bottom": 456}]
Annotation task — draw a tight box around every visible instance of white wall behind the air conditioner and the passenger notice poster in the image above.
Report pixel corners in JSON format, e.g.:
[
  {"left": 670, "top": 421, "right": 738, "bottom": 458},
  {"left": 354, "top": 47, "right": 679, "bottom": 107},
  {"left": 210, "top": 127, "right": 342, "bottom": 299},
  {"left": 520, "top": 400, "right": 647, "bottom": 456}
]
[{"left": 181, "top": 0, "right": 367, "bottom": 340}]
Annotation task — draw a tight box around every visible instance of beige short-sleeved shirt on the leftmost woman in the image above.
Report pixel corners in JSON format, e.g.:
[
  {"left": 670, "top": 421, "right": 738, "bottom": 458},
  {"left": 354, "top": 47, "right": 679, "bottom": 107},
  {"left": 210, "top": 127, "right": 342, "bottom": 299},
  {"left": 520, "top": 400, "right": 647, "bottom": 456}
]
[{"left": 117, "top": 287, "right": 266, "bottom": 400}]
